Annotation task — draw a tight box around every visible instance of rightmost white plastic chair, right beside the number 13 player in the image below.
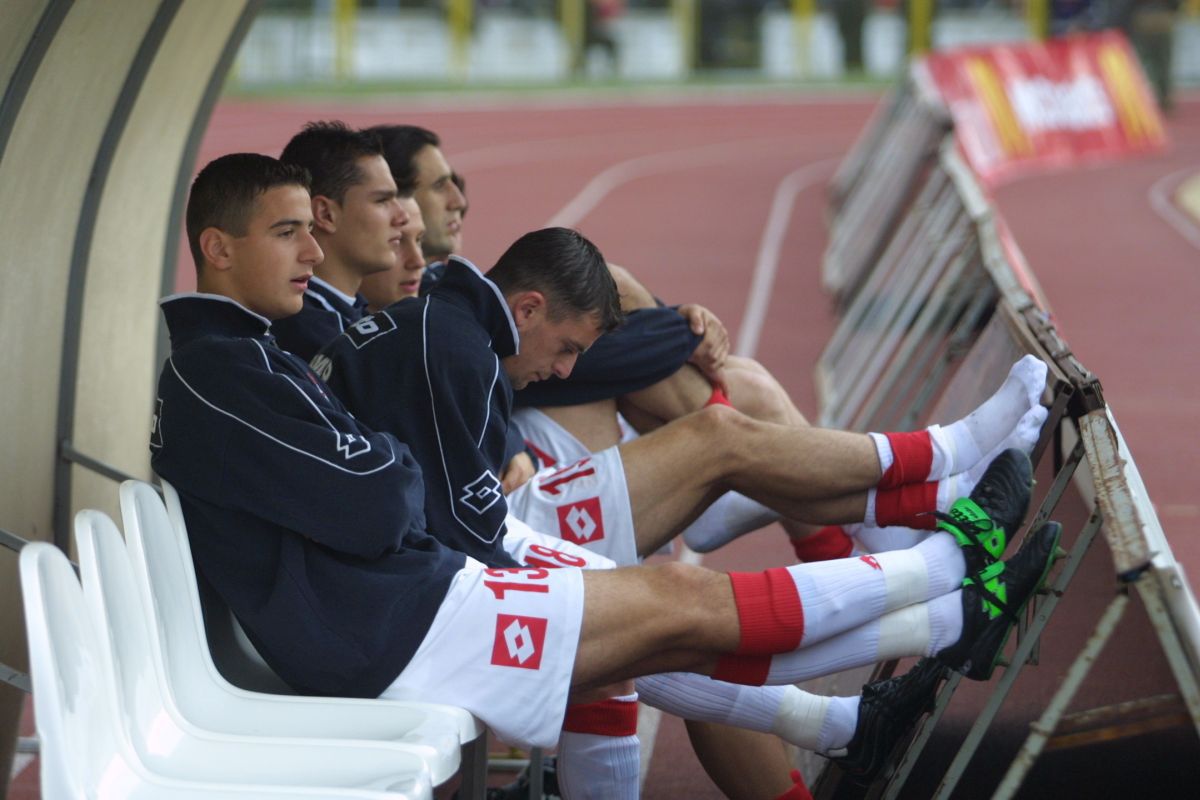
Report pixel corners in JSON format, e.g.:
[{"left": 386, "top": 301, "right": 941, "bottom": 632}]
[{"left": 121, "top": 481, "right": 486, "bottom": 784}]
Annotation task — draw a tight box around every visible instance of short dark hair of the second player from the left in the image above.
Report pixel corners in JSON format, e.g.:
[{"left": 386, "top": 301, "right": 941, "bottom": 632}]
[{"left": 280, "top": 120, "right": 383, "bottom": 203}]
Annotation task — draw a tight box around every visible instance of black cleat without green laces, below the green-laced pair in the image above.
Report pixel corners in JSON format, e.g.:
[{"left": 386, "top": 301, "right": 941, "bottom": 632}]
[{"left": 833, "top": 658, "right": 946, "bottom": 786}]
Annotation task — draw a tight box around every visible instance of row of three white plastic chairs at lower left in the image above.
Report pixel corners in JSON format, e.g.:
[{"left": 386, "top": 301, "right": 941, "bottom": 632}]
[{"left": 20, "top": 481, "right": 482, "bottom": 800}]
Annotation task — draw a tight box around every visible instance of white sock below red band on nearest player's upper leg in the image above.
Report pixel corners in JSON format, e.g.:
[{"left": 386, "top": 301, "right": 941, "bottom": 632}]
[{"left": 787, "top": 534, "right": 966, "bottom": 646}]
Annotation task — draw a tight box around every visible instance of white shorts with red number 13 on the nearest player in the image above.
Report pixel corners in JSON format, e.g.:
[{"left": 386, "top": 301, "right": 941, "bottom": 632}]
[{"left": 379, "top": 560, "right": 583, "bottom": 747}]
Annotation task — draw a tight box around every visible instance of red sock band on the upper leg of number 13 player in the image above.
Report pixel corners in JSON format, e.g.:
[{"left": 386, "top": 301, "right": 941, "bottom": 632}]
[{"left": 730, "top": 567, "right": 804, "bottom": 656}]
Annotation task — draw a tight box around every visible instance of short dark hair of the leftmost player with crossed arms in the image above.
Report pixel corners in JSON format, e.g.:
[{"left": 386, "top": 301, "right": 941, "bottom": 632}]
[{"left": 186, "top": 152, "right": 311, "bottom": 270}]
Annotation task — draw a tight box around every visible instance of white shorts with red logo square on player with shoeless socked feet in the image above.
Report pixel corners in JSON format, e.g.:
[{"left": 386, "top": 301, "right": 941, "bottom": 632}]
[{"left": 508, "top": 447, "right": 637, "bottom": 566}]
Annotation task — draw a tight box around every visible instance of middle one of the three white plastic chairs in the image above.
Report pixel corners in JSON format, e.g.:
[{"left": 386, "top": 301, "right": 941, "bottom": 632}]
[{"left": 76, "top": 511, "right": 433, "bottom": 798}]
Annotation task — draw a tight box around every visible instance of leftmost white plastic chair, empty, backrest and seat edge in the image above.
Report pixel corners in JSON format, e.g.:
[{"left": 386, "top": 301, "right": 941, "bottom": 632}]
[{"left": 19, "top": 542, "right": 422, "bottom": 800}]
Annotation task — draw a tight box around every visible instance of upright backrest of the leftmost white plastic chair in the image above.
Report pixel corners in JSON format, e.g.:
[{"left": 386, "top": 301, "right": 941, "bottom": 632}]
[{"left": 20, "top": 542, "right": 124, "bottom": 800}]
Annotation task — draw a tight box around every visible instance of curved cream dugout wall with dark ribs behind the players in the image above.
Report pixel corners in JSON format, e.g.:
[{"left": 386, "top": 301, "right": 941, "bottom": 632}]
[{"left": 0, "top": 0, "right": 260, "bottom": 789}]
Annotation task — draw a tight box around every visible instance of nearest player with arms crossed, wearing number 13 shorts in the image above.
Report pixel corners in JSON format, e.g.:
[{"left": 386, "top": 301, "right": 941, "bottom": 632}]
[{"left": 151, "top": 155, "right": 1057, "bottom": 762}]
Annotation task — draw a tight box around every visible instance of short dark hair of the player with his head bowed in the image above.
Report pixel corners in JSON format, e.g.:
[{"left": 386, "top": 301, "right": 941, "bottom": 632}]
[{"left": 487, "top": 228, "right": 624, "bottom": 332}]
